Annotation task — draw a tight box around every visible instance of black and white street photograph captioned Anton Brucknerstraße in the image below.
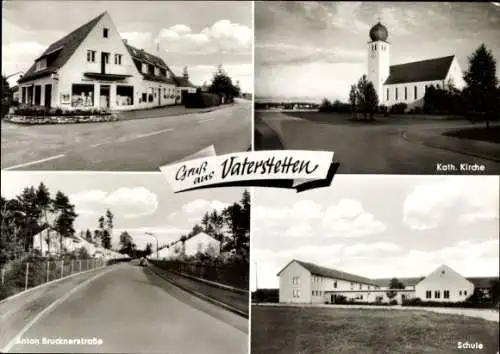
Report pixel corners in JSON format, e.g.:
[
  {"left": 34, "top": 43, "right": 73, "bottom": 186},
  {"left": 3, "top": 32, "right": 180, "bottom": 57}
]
[{"left": 0, "top": 171, "right": 250, "bottom": 354}]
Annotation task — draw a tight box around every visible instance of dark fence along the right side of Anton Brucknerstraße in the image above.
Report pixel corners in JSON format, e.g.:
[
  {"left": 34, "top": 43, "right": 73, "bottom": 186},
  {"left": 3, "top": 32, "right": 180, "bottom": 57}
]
[{"left": 152, "top": 260, "right": 249, "bottom": 290}]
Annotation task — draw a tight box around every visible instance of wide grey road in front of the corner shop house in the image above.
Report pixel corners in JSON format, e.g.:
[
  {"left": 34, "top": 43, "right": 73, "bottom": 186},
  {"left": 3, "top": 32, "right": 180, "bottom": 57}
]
[{"left": 1, "top": 100, "right": 252, "bottom": 171}]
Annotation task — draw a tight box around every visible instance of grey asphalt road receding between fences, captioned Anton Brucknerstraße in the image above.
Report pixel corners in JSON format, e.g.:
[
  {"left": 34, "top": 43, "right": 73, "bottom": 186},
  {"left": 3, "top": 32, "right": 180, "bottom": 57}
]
[{"left": 5, "top": 264, "right": 248, "bottom": 354}]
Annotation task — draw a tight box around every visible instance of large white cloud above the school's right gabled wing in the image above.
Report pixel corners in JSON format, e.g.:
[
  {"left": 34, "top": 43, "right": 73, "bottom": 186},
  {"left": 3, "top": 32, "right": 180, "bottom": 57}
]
[{"left": 403, "top": 176, "right": 499, "bottom": 230}]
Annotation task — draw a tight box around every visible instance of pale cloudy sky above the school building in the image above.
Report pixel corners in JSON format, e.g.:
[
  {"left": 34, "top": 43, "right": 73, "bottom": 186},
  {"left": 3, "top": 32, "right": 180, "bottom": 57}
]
[{"left": 250, "top": 175, "right": 500, "bottom": 290}]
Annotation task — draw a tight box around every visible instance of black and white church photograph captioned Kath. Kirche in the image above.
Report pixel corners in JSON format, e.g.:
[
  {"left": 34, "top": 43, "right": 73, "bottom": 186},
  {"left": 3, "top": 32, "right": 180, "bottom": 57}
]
[{"left": 254, "top": 1, "right": 500, "bottom": 175}]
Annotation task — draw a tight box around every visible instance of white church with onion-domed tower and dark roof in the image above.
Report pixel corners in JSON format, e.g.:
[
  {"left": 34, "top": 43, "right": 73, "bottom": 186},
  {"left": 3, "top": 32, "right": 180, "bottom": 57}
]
[{"left": 367, "top": 22, "right": 465, "bottom": 109}]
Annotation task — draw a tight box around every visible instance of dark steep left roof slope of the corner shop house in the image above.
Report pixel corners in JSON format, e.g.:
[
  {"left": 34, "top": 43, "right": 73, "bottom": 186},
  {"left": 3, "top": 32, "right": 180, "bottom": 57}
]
[{"left": 18, "top": 12, "right": 106, "bottom": 83}]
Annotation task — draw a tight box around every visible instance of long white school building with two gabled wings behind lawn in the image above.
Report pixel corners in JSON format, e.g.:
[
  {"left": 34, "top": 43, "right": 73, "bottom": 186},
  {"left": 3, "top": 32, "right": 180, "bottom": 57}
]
[{"left": 278, "top": 260, "right": 498, "bottom": 303}]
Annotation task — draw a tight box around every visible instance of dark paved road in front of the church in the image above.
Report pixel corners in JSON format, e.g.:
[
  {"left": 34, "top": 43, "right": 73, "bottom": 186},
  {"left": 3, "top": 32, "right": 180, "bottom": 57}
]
[{"left": 256, "top": 112, "right": 500, "bottom": 175}]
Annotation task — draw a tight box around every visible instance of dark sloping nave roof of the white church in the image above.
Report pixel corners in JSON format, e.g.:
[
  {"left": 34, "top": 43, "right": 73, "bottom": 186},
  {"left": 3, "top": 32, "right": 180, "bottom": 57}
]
[{"left": 384, "top": 55, "right": 455, "bottom": 85}]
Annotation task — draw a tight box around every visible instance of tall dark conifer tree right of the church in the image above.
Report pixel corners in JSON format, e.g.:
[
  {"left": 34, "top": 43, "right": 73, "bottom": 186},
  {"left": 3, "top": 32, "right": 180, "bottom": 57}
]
[{"left": 464, "top": 44, "right": 498, "bottom": 129}]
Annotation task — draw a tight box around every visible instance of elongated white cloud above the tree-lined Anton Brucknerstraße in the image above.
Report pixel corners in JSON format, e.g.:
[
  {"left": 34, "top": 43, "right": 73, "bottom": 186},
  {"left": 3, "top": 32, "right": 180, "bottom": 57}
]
[{"left": 70, "top": 187, "right": 158, "bottom": 218}]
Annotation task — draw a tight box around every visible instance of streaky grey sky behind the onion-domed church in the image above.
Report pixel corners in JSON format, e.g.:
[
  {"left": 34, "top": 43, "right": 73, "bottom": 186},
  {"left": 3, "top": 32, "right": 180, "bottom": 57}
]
[{"left": 255, "top": 1, "right": 500, "bottom": 101}]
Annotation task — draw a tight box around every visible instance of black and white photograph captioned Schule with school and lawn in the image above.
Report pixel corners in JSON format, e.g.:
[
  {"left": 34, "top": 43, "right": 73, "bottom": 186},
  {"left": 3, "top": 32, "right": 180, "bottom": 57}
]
[{"left": 250, "top": 175, "right": 500, "bottom": 354}]
